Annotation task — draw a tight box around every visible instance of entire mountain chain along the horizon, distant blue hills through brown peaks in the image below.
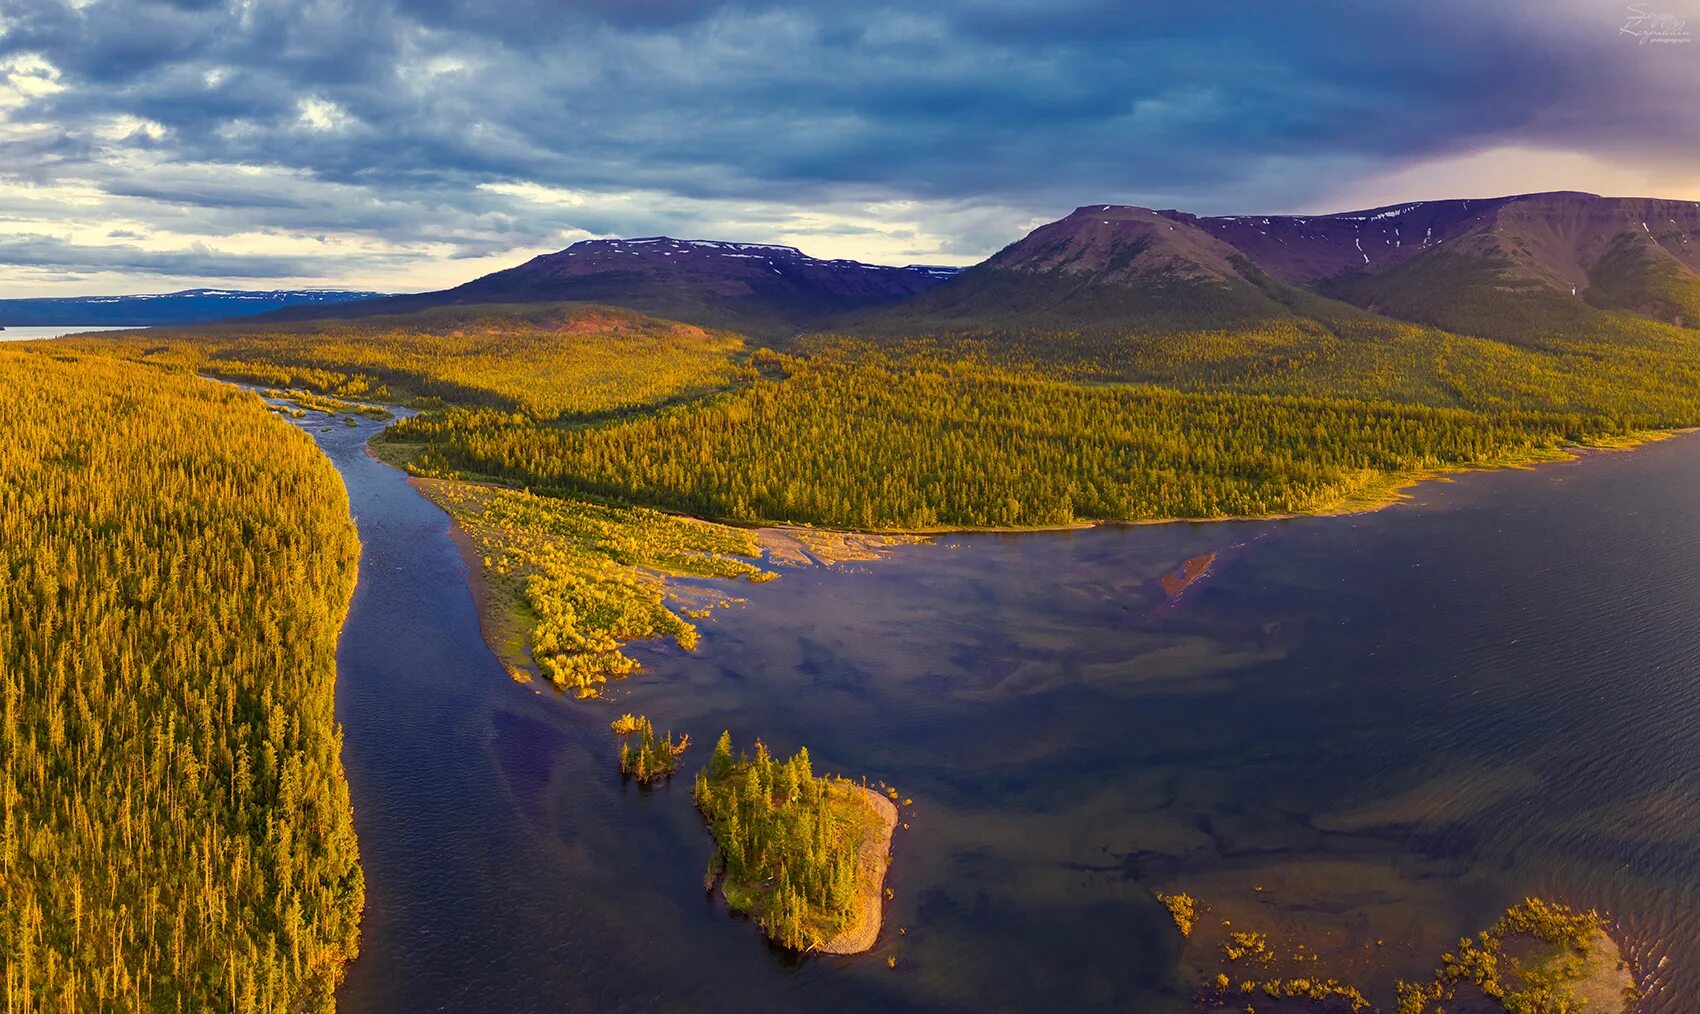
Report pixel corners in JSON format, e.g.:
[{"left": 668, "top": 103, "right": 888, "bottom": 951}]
[{"left": 23, "top": 192, "right": 1700, "bottom": 344}]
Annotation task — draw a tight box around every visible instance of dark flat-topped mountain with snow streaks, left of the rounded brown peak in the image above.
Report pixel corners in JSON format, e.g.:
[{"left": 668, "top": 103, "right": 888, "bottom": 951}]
[{"left": 263, "top": 236, "right": 955, "bottom": 339}]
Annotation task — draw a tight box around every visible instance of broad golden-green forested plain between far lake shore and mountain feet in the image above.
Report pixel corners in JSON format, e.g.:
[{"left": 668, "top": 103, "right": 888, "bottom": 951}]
[{"left": 71, "top": 301, "right": 1700, "bottom": 529}]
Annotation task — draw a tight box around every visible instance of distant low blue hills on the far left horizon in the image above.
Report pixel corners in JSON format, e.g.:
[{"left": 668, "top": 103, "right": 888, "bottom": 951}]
[{"left": 0, "top": 289, "right": 381, "bottom": 327}]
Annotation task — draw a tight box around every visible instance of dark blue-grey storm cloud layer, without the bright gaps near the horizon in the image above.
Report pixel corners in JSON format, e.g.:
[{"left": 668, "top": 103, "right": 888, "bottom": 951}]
[{"left": 0, "top": 0, "right": 1700, "bottom": 287}]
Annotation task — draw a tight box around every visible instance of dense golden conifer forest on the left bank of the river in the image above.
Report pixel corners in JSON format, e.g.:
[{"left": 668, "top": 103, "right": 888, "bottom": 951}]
[{"left": 0, "top": 352, "right": 364, "bottom": 1012}]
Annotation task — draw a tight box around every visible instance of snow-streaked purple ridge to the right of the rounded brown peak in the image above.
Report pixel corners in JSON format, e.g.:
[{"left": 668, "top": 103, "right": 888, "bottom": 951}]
[{"left": 1165, "top": 192, "right": 1700, "bottom": 340}]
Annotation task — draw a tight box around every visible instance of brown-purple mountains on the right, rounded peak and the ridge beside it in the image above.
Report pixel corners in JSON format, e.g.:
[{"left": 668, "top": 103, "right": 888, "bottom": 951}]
[{"left": 852, "top": 192, "right": 1700, "bottom": 340}]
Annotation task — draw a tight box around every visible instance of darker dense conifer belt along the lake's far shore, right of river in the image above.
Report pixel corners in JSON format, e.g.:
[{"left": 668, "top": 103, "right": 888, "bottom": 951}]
[{"left": 382, "top": 352, "right": 1632, "bottom": 529}]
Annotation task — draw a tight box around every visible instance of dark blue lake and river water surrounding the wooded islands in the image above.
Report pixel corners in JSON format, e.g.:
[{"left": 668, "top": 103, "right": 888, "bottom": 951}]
[{"left": 308, "top": 406, "right": 1700, "bottom": 1012}]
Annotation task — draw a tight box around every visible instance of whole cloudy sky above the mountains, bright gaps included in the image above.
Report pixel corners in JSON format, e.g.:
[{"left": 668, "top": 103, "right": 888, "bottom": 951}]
[{"left": 0, "top": 0, "right": 1700, "bottom": 298}]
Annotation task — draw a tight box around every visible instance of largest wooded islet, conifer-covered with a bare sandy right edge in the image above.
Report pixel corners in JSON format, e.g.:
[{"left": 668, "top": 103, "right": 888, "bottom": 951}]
[{"left": 695, "top": 732, "right": 898, "bottom": 954}]
